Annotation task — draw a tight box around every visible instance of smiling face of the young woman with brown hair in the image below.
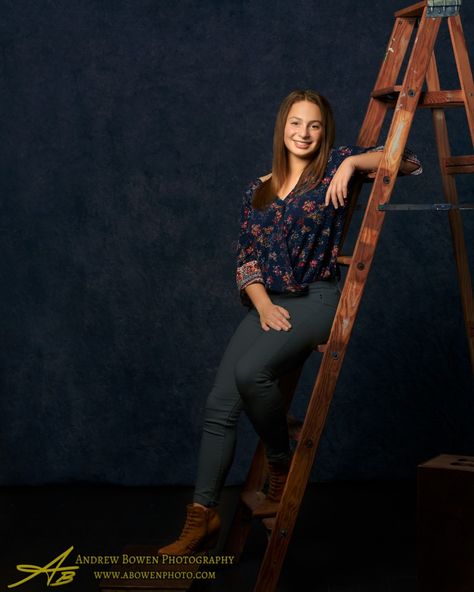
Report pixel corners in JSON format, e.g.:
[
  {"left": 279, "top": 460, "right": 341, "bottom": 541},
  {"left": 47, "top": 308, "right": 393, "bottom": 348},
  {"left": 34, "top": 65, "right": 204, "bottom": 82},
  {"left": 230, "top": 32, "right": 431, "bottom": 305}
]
[{"left": 284, "top": 101, "right": 324, "bottom": 160}]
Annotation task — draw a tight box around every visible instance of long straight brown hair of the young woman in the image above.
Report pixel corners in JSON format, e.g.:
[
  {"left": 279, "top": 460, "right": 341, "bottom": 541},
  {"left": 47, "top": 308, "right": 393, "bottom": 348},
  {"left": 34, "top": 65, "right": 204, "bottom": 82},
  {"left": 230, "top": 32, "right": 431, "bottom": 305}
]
[{"left": 252, "top": 90, "right": 336, "bottom": 209}]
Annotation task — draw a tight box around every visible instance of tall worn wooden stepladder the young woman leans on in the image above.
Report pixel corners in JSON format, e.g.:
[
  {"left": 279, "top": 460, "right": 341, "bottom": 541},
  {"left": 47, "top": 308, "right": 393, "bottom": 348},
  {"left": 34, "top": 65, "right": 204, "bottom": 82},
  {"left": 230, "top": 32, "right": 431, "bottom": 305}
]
[{"left": 224, "top": 0, "right": 474, "bottom": 592}]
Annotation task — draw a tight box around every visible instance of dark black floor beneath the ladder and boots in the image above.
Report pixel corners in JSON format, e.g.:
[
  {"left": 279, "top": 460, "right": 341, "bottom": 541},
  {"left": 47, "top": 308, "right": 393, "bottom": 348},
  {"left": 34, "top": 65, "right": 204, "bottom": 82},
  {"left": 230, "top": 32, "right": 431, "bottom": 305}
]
[{"left": 0, "top": 481, "right": 416, "bottom": 592}]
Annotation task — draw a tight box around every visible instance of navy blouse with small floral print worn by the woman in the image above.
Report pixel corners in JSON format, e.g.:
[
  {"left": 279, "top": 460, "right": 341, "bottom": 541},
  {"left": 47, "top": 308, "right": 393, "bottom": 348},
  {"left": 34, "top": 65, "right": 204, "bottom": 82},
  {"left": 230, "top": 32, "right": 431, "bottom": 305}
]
[{"left": 236, "top": 145, "right": 423, "bottom": 307}]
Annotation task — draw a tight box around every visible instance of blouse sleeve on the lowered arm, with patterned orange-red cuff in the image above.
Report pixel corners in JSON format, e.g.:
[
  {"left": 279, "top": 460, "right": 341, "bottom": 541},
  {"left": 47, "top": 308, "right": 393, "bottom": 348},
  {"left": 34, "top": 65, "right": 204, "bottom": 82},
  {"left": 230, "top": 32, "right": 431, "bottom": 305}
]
[{"left": 236, "top": 178, "right": 264, "bottom": 298}]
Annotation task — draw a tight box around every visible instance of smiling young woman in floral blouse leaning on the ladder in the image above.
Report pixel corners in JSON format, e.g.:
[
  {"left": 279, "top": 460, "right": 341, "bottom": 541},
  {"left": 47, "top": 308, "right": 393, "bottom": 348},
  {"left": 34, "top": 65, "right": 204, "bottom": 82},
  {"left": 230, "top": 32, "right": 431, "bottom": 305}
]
[{"left": 159, "top": 90, "right": 422, "bottom": 554}]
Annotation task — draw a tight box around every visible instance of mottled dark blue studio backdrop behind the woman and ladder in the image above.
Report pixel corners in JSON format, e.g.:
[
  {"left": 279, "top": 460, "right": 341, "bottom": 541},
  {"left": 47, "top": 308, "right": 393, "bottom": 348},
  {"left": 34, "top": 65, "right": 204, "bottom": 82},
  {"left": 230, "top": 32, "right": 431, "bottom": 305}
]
[{"left": 0, "top": 0, "right": 474, "bottom": 485}]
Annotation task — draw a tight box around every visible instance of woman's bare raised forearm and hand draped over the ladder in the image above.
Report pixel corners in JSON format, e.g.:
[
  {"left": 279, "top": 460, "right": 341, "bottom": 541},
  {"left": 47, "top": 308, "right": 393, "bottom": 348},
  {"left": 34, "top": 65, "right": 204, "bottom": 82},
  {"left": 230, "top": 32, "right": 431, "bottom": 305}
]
[{"left": 324, "top": 151, "right": 420, "bottom": 209}]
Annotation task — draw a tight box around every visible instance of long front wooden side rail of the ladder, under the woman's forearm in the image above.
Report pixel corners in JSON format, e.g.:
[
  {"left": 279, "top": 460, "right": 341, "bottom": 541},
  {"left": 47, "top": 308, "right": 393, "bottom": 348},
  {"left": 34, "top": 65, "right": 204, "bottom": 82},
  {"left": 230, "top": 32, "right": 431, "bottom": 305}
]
[{"left": 254, "top": 8, "right": 440, "bottom": 592}]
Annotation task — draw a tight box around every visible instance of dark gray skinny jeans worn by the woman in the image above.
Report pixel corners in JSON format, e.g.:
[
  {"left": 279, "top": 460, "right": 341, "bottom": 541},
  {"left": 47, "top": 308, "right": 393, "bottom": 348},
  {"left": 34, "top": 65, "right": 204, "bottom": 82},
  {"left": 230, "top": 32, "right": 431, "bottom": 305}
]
[{"left": 193, "top": 280, "right": 341, "bottom": 506}]
